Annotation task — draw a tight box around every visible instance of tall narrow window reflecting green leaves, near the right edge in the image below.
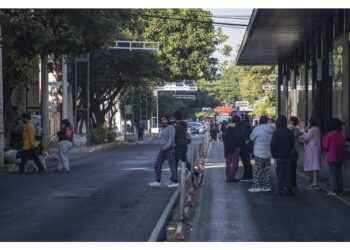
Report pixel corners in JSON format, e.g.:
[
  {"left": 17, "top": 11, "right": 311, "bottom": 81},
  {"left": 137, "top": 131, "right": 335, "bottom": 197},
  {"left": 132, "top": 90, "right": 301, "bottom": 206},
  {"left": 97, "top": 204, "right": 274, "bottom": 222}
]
[{"left": 332, "top": 45, "right": 343, "bottom": 120}]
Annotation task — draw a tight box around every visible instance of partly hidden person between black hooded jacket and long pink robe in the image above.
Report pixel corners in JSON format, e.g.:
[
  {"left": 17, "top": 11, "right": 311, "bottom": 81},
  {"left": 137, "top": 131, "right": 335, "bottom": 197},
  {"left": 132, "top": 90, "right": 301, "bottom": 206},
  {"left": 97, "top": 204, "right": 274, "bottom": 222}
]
[{"left": 288, "top": 116, "right": 300, "bottom": 188}]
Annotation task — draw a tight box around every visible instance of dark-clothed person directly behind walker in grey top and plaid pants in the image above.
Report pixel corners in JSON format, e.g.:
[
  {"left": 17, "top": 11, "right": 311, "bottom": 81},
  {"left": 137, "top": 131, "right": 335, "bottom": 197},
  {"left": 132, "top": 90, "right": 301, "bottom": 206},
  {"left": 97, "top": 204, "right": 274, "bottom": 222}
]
[{"left": 174, "top": 111, "right": 203, "bottom": 184}]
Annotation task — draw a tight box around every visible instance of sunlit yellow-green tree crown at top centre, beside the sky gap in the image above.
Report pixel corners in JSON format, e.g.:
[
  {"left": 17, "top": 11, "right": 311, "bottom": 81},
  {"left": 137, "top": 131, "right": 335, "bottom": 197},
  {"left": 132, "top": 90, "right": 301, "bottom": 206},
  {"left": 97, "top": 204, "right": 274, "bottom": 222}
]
[{"left": 135, "top": 9, "right": 227, "bottom": 80}]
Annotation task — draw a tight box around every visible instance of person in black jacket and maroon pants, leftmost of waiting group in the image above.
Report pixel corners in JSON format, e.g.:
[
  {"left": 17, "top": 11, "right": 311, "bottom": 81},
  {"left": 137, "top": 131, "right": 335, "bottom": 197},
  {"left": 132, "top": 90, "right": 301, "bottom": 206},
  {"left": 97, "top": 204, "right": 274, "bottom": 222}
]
[{"left": 224, "top": 116, "right": 243, "bottom": 182}]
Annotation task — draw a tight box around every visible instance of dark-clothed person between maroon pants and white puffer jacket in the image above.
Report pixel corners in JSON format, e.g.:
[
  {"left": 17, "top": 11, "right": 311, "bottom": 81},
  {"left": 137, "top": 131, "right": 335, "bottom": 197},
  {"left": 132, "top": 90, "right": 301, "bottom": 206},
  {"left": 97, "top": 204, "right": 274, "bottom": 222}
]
[{"left": 240, "top": 115, "right": 253, "bottom": 181}]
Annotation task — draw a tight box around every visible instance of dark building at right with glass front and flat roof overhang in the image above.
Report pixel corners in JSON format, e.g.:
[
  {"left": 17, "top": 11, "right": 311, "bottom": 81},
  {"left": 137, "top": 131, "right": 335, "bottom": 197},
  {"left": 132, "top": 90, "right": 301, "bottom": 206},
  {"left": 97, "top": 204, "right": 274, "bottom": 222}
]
[{"left": 237, "top": 9, "right": 350, "bottom": 186}]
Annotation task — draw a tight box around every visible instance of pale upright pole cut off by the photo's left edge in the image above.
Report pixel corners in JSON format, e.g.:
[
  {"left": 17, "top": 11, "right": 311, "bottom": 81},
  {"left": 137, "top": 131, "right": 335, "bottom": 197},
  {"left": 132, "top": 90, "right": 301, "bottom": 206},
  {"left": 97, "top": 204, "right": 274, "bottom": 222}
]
[{"left": 0, "top": 25, "right": 5, "bottom": 167}]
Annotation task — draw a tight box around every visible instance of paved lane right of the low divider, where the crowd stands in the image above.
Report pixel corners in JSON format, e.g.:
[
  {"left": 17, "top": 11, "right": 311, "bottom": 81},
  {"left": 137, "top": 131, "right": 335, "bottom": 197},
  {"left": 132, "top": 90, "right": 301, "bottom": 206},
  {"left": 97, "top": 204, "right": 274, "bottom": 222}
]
[{"left": 186, "top": 142, "right": 350, "bottom": 242}]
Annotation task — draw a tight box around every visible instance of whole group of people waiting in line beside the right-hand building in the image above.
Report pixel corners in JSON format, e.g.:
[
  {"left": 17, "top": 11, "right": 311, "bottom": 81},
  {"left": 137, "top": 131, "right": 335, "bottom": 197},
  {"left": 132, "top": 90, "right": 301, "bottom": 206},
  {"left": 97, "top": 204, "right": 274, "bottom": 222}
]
[{"left": 220, "top": 115, "right": 345, "bottom": 196}]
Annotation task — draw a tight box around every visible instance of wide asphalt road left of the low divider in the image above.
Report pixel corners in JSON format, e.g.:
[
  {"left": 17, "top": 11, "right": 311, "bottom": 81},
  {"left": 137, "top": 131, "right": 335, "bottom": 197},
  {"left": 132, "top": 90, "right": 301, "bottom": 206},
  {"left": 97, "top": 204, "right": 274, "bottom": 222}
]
[{"left": 0, "top": 142, "right": 180, "bottom": 241}]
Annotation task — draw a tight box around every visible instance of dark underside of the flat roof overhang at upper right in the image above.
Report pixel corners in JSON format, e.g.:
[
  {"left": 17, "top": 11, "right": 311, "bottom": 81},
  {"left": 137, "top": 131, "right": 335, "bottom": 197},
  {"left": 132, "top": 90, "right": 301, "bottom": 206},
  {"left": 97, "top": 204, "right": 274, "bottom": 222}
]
[{"left": 236, "top": 9, "right": 333, "bottom": 65}]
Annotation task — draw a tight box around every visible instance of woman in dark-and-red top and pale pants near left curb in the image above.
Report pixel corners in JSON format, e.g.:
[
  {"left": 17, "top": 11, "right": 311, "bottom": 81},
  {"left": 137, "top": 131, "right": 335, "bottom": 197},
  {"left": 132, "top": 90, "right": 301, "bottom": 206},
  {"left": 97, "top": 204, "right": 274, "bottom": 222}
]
[{"left": 57, "top": 119, "right": 73, "bottom": 172}]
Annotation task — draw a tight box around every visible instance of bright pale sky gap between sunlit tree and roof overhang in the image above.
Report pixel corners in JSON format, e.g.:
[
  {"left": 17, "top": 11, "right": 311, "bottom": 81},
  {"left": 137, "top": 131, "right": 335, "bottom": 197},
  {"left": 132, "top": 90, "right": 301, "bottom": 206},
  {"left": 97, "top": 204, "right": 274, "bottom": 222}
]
[{"left": 204, "top": 8, "right": 253, "bottom": 62}]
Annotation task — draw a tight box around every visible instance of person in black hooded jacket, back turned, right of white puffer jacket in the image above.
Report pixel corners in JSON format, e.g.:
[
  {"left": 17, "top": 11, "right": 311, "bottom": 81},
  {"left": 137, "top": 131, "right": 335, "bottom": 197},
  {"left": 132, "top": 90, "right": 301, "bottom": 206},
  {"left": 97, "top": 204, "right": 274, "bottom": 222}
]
[{"left": 270, "top": 115, "right": 295, "bottom": 195}]
